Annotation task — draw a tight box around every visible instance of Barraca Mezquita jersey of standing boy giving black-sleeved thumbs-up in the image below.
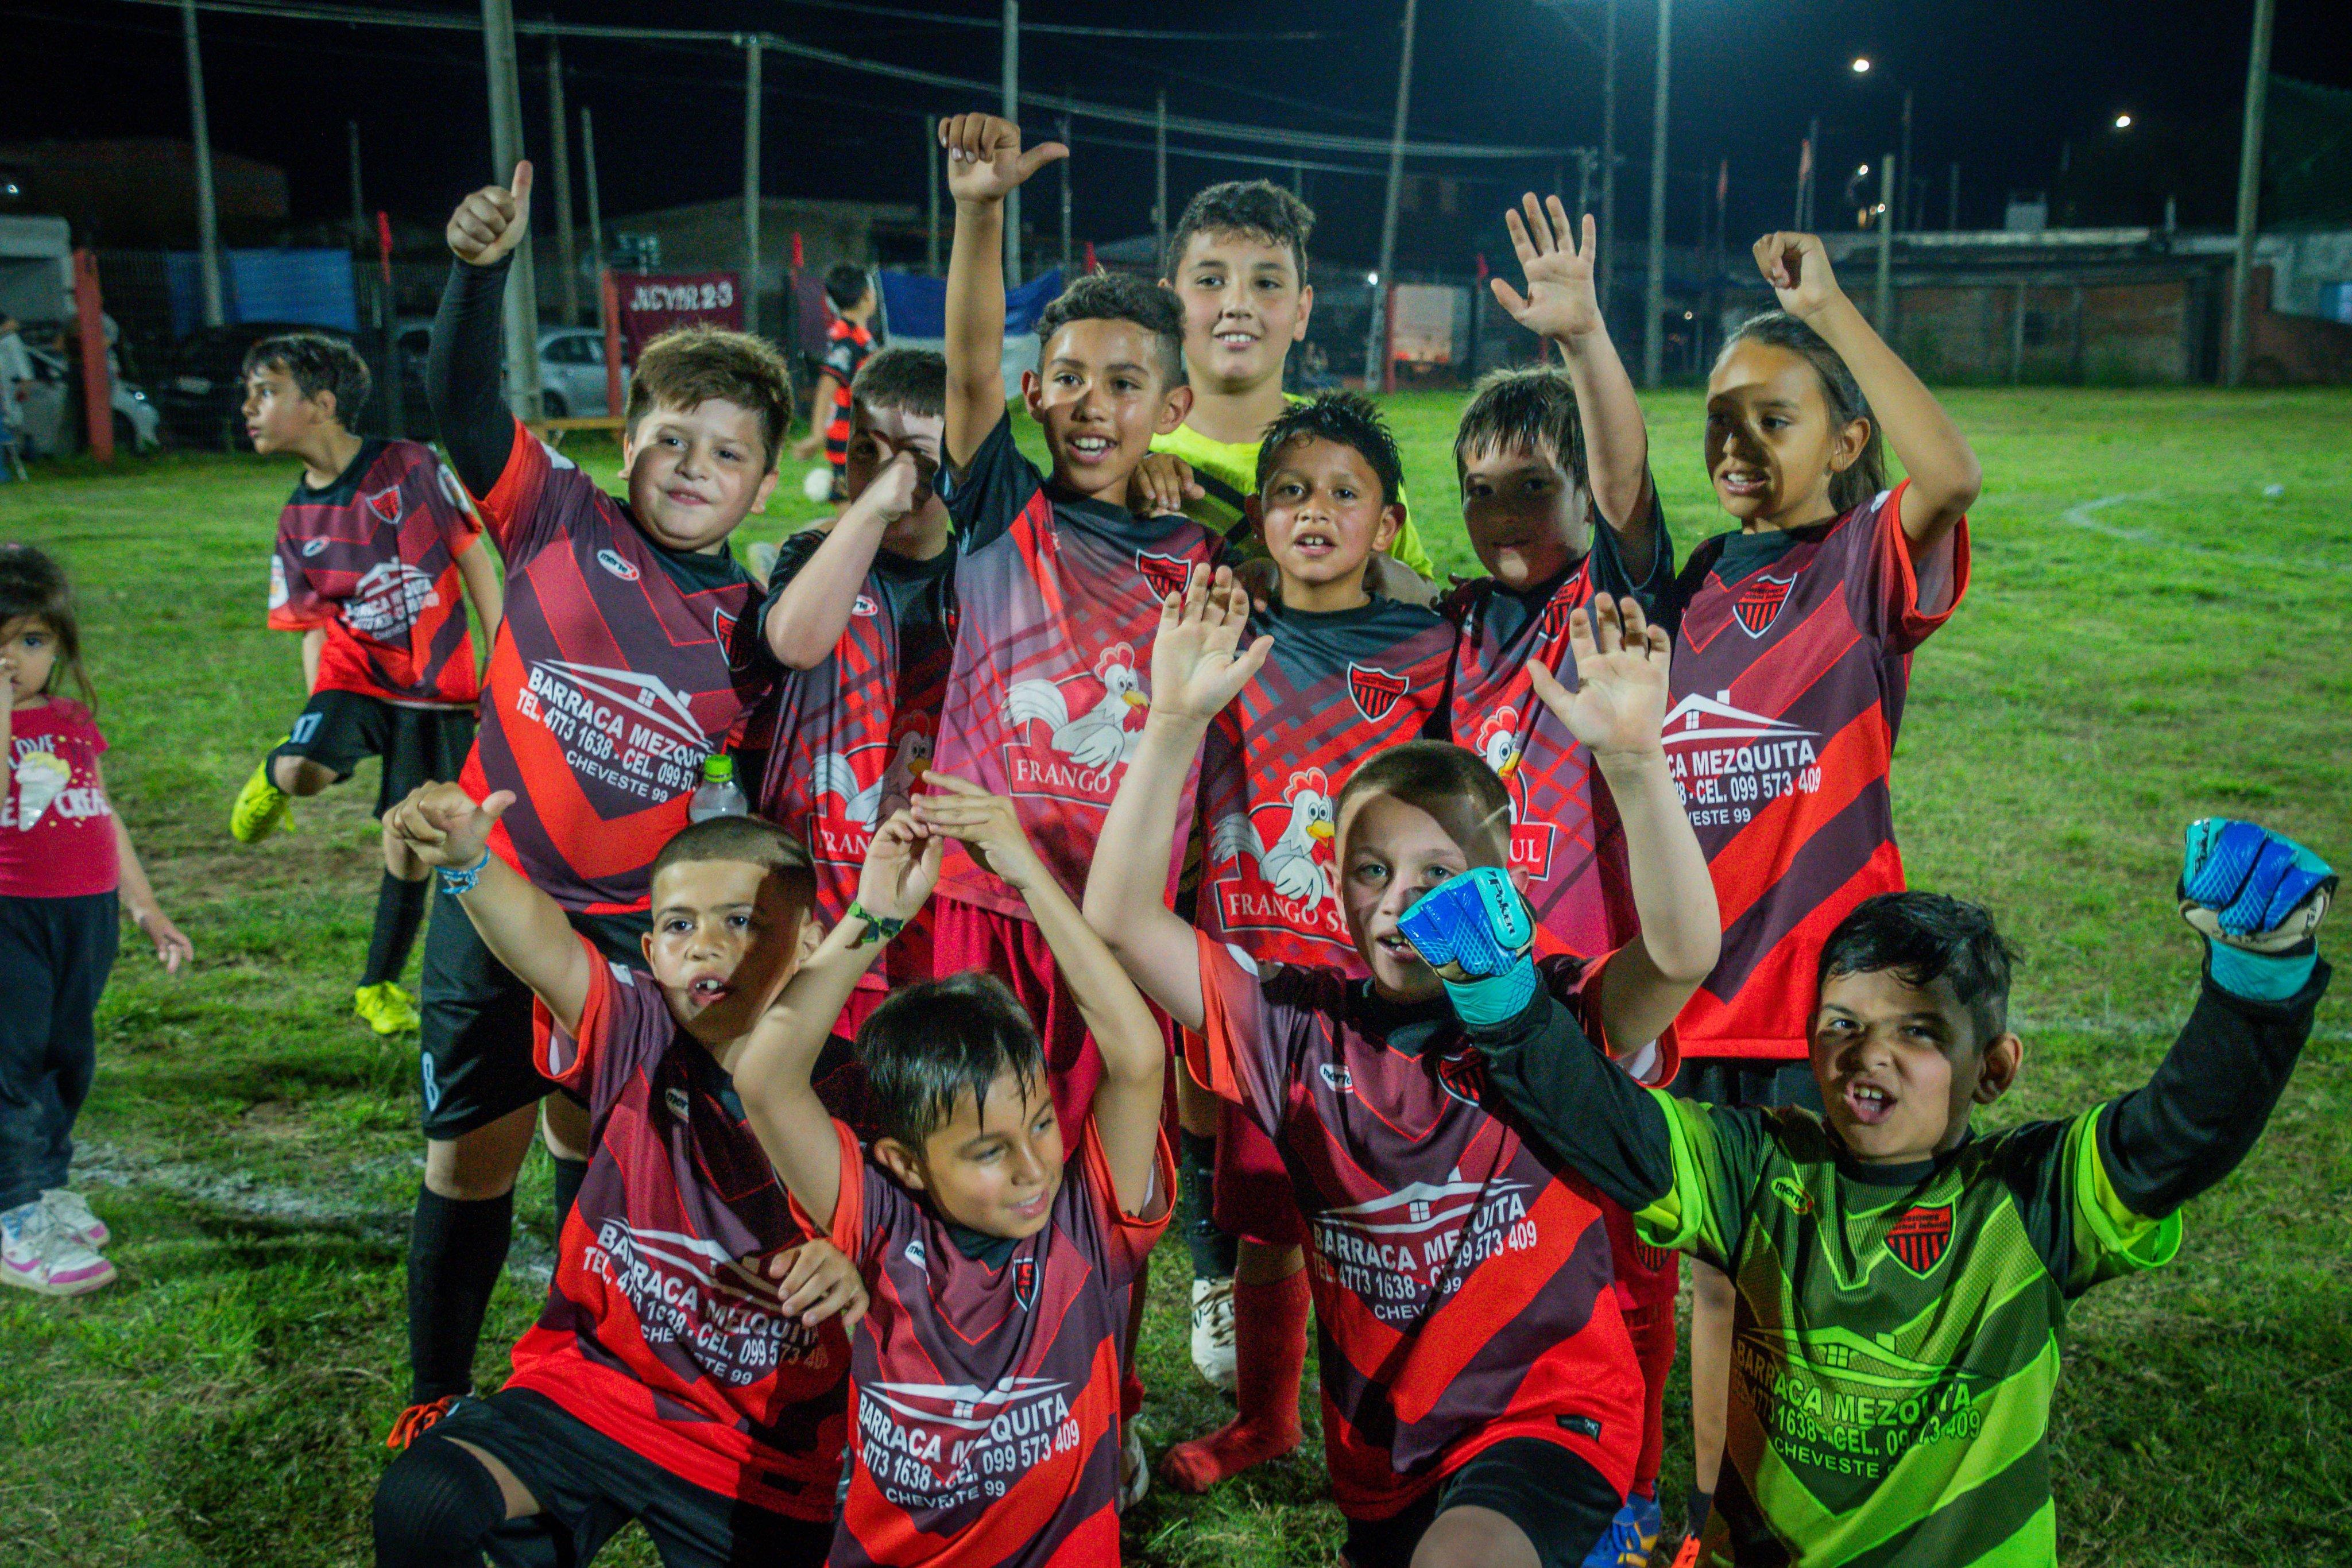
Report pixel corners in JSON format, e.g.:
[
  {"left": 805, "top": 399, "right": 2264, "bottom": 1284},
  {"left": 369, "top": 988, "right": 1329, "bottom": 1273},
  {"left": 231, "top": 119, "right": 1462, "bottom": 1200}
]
[{"left": 449, "top": 421, "right": 776, "bottom": 915}]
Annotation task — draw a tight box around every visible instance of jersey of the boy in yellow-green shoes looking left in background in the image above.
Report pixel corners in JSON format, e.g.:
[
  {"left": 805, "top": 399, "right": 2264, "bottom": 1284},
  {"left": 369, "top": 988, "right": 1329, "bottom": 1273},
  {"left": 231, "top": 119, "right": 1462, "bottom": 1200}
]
[{"left": 270, "top": 440, "right": 482, "bottom": 707}]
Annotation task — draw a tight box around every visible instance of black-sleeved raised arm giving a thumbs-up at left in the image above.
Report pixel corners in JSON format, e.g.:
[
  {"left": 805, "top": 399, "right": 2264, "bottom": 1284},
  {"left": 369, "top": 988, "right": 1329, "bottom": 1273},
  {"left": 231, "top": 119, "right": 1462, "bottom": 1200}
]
[{"left": 425, "top": 162, "right": 532, "bottom": 496}]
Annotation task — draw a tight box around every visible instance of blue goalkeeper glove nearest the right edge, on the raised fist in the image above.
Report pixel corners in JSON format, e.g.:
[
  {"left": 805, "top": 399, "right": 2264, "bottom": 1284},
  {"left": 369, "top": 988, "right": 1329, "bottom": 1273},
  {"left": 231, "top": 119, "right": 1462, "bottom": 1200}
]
[{"left": 2178, "top": 816, "right": 2335, "bottom": 1001}]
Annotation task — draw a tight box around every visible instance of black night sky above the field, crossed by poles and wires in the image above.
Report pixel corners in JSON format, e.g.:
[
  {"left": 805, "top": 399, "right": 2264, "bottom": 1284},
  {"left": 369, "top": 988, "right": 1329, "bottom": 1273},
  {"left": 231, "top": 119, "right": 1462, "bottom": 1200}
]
[{"left": 14, "top": 0, "right": 2352, "bottom": 268}]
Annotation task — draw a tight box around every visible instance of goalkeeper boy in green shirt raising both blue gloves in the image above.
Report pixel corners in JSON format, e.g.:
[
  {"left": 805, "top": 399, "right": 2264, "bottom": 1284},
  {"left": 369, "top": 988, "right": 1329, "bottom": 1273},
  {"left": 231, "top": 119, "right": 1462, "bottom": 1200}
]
[{"left": 1402, "top": 818, "right": 2335, "bottom": 1568}]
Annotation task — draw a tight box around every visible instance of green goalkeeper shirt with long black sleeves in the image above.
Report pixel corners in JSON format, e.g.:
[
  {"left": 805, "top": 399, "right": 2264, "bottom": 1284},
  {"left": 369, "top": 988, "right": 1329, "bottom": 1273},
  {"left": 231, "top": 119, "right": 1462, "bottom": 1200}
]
[{"left": 1472, "top": 964, "right": 2326, "bottom": 1568}]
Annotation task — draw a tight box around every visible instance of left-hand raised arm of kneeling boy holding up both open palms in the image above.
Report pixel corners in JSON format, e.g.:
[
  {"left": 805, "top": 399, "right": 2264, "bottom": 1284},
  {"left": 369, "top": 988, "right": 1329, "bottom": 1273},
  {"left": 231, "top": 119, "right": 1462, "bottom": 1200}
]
[{"left": 1084, "top": 567, "right": 1275, "bottom": 1029}]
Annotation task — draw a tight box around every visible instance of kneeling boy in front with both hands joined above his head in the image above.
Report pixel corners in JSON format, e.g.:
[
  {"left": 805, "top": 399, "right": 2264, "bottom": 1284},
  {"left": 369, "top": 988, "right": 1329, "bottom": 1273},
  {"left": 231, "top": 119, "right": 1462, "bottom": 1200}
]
[{"left": 741, "top": 773, "right": 1176, "bottom": 1568}]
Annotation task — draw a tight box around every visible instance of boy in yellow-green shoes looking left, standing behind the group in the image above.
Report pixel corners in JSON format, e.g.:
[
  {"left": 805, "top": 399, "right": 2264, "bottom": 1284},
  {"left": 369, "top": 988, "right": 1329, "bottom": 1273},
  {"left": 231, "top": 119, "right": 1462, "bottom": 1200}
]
[{"left": 228, "top": 331, "right": 501, "bottom": 1035}]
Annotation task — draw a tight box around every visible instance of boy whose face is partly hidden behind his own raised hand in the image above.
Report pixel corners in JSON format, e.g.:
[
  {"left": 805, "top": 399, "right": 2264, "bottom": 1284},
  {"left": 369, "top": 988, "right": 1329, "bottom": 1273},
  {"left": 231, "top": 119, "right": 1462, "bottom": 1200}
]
[{"left": 751, "top": 348, "right": 955, "bottom": 1035}]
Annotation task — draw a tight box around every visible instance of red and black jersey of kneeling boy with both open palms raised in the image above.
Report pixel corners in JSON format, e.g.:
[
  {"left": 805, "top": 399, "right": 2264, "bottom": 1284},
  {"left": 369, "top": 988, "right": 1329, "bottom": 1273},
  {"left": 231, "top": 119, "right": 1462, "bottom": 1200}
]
[{"left": 1185, "top": 933, "right": 1672, "bottom": 1519}]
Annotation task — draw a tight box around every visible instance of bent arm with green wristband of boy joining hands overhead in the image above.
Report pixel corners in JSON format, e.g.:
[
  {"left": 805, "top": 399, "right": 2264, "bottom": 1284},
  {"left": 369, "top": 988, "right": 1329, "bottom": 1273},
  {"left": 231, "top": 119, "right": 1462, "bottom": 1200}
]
[{"left": 717, "top": 811, "right": 941, "bottom": 1227}]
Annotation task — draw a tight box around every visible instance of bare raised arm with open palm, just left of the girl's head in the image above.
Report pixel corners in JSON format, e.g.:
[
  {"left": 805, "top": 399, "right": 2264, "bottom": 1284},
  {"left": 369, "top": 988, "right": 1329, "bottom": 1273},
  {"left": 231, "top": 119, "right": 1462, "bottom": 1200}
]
[{"left": 1491, "top": 193, "right": 1658, "bottom": 583}]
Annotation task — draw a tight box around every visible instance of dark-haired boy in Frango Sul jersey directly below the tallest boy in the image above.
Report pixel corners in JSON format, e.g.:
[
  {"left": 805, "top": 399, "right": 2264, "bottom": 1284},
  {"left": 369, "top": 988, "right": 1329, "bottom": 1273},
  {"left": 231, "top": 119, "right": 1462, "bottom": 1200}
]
[{"left": 1159, "top": 393, "right": 1453, "bottom": 1493}]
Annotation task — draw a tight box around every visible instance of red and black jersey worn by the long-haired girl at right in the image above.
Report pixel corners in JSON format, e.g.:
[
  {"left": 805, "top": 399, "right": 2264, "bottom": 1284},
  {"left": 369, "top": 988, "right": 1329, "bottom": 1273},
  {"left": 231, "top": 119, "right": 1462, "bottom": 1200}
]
[{"left": 1665, "top": 484, "right": 1968, "bottom": 1060}]
